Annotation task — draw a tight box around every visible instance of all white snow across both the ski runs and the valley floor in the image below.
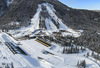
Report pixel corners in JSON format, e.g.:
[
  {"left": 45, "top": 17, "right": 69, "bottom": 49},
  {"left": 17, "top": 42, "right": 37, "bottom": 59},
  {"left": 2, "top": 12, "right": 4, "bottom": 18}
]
[{"left": 0, "top": 3, "right": 100, "bottom": 68}]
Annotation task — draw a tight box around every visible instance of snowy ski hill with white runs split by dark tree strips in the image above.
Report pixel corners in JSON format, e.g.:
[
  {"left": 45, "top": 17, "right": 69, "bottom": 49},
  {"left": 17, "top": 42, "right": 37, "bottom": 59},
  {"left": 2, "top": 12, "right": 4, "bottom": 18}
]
[{"left": 9, "top": 3, "right": 83, "bottom": 38}]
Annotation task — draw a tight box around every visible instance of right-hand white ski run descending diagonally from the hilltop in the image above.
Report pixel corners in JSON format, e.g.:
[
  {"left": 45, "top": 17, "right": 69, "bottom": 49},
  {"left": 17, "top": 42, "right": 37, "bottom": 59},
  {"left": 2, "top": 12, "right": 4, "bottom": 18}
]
[{"left": 43, "top": 3, "right": 80, "bottom": 37}]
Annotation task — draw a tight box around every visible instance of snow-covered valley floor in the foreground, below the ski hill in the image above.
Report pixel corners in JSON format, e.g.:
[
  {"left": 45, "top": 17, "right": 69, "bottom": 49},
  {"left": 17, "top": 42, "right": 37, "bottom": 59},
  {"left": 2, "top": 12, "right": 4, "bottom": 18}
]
[{"left": 0, "top": 33, "right": 100, "bottom": 68}]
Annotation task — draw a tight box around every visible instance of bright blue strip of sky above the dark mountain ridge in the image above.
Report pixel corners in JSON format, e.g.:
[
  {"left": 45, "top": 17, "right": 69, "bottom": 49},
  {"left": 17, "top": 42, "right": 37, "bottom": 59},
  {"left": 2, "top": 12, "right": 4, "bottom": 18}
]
[{"left": 59, "top": 0, "right": 100, "bottom": 10}]
